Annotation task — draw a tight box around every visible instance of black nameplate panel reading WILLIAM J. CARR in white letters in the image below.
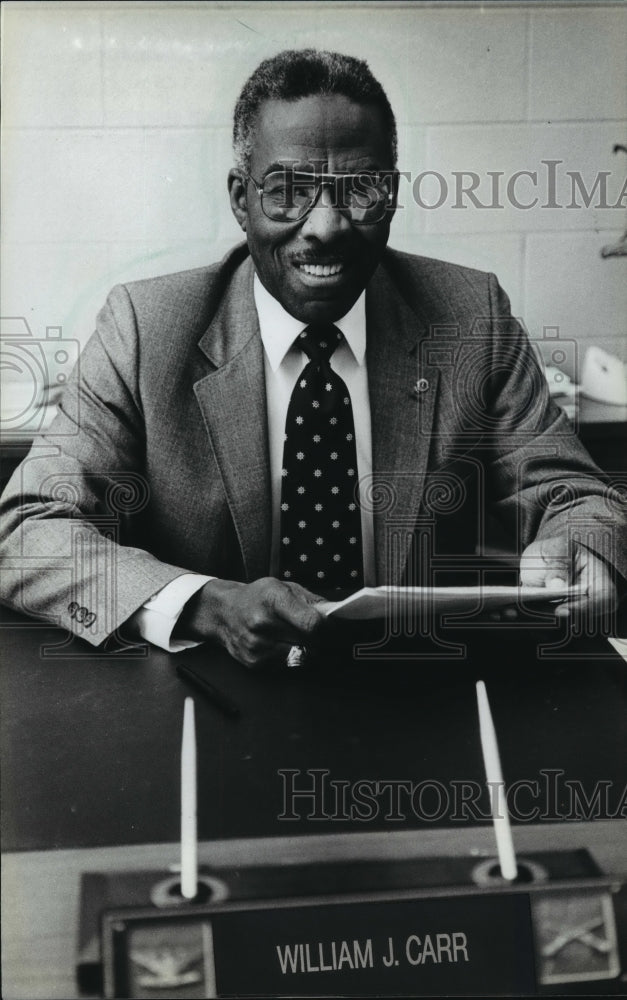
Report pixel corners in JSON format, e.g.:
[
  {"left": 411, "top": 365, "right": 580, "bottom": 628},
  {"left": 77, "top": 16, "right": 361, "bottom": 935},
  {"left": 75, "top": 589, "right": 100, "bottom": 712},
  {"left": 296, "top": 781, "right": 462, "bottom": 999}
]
[{"left": 213, "top": 894, "right": 535, "bottom": 996}]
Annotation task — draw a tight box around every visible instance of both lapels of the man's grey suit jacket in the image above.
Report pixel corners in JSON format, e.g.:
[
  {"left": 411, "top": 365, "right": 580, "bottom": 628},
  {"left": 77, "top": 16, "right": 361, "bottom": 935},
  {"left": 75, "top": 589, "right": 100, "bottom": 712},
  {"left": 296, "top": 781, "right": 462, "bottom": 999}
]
[{"left": 194, "top": 250, "right": 439, "bottom": 584}]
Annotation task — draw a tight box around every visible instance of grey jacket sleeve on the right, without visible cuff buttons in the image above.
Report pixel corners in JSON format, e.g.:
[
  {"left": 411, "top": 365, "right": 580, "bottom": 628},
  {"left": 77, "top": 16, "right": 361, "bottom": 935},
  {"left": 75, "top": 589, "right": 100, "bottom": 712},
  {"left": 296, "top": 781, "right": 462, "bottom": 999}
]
[{"left": 484, "top": 275, "right": 627, "bottom": 577}]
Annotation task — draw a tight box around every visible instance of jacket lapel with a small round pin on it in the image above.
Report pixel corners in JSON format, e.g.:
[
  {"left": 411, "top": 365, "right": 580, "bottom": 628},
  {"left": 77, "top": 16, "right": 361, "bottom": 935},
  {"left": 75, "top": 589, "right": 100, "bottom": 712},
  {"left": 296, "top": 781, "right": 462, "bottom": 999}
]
[{"left": 366, "top": 267, "right": 439, "bottom": 584}]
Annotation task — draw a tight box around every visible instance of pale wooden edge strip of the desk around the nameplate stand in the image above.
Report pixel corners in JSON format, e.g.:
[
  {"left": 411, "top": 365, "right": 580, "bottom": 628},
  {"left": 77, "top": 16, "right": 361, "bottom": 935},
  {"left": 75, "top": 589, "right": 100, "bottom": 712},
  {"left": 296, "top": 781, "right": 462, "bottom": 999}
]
[{"left": 2, "top": 821, "right": 627, "bottom": 1000}]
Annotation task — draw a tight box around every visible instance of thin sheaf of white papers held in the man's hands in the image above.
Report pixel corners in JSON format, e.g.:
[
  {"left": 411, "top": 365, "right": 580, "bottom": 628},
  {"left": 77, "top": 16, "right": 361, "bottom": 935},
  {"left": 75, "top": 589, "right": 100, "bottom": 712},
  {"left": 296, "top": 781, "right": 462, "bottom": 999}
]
[{"left": 317, "top": 586, "right": 582, "bottom": 620}]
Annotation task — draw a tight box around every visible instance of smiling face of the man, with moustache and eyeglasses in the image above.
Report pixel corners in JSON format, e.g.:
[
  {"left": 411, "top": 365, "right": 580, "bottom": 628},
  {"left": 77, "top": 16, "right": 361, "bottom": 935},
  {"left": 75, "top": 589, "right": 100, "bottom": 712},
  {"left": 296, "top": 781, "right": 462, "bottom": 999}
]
[{"left": 229, "top": 92, "right": 395, "bottom": 323}]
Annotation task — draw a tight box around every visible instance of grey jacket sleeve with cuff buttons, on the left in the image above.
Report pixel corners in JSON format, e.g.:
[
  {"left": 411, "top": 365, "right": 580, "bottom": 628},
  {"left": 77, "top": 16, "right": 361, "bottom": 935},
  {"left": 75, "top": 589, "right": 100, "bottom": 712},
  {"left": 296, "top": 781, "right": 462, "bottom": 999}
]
[{"left": 0, "top": 286, "right": 194, "bottom": 645}]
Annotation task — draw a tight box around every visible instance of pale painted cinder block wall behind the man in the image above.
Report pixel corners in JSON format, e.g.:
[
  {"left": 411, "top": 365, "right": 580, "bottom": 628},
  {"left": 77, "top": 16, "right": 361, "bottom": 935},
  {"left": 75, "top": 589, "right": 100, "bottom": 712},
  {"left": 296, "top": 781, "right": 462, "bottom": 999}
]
[{"left": 2, "top": 2, "right": 627, "bottom": 373}]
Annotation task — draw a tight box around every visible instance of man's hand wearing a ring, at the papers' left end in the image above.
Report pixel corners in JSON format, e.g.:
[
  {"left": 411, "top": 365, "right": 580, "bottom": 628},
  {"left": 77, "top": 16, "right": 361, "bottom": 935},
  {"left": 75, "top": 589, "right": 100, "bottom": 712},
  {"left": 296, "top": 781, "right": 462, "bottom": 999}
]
[{"left": 176, "top": 577, "right": 324, "bottom": 667}]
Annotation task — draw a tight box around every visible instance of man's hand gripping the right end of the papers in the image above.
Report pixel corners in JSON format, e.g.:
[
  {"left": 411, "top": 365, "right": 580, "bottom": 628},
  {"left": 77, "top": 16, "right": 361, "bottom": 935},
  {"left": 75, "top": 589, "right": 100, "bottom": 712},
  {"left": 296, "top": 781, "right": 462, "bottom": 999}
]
[{"left": 520, "top": 536, "right": 618, "bottom": 618}]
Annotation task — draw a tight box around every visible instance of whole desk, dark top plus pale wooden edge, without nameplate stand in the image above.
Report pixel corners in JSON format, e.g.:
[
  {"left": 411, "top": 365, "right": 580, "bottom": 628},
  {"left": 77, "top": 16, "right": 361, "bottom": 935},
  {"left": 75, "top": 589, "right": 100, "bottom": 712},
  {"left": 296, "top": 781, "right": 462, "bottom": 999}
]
[{"left": 1, "top": 613, "right": 627, "bottom": 1000}]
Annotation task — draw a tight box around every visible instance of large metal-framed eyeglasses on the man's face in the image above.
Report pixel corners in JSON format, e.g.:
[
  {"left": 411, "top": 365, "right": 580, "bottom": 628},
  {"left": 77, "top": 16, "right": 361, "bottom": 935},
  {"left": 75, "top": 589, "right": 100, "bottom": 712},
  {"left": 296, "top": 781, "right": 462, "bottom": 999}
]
[{"left": 248, "top": 170, "right": 394, "bottom": 226}]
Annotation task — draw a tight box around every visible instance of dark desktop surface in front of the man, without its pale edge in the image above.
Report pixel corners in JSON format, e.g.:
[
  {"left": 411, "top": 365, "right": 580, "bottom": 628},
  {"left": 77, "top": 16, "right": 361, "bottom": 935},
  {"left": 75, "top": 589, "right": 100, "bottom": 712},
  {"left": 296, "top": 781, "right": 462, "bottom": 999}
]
[{"left": 0, "top": 613, "right": 627, "bottom": 851}]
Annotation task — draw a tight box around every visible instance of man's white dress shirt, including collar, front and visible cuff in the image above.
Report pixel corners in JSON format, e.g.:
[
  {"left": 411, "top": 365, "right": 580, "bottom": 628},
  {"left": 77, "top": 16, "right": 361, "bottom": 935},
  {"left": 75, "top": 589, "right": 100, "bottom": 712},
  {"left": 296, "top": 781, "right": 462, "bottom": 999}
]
[{"left": 131, "top": 275, "right": 375, "bottom": 653}]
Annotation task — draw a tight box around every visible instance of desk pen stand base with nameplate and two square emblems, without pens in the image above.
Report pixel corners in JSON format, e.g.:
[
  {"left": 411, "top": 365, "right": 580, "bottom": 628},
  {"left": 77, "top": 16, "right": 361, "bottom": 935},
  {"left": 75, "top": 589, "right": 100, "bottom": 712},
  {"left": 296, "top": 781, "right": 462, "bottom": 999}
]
[{"left": 78, "top": 850, "right": 627, "bottom": 1000}]
